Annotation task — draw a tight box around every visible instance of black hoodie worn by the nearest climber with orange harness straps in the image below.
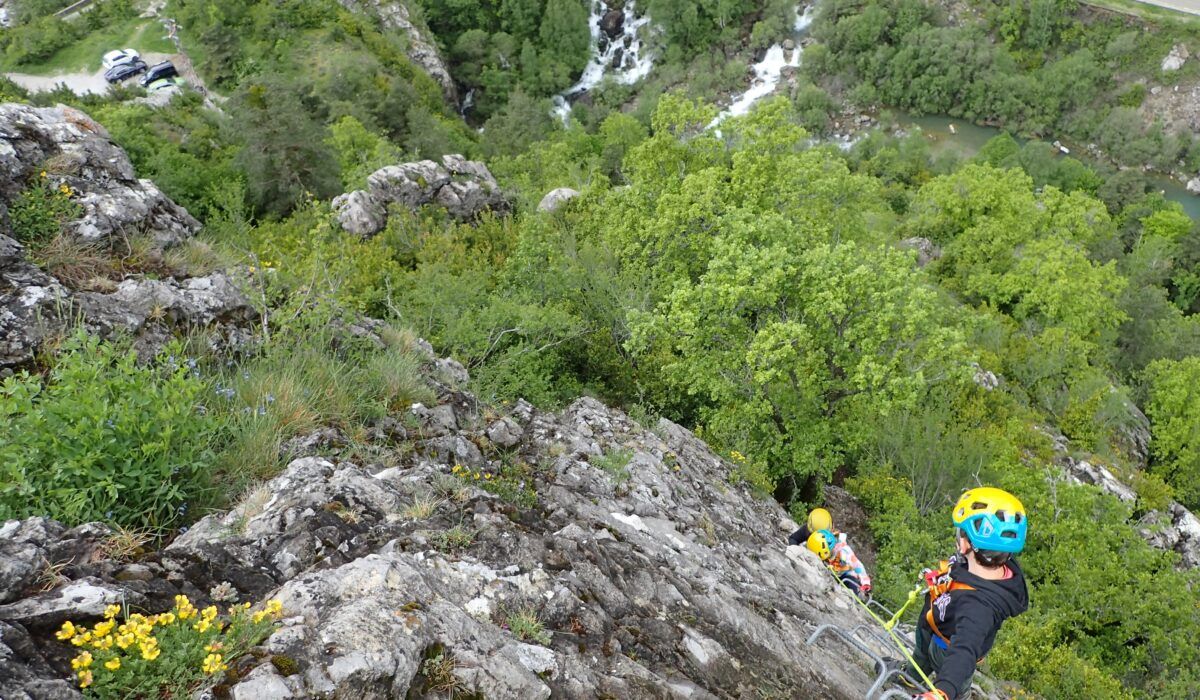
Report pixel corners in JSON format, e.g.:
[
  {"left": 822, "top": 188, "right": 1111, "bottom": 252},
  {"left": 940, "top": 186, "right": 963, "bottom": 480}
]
[{"left": 919, "top": 558, "right": 1030, "bottom": 700}]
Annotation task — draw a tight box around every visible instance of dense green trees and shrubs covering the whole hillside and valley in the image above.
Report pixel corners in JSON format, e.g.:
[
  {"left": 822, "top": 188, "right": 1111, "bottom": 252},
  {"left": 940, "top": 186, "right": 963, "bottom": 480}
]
[{"left": 0, "top": 0, "right": 1200, "bottom": 699}]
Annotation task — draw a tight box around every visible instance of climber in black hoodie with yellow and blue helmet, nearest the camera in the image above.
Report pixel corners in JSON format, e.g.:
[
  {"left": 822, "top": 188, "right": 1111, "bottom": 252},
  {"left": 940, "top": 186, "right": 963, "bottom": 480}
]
[{"left": 908, "top": 487, "right": 1030, "bottom": 700}]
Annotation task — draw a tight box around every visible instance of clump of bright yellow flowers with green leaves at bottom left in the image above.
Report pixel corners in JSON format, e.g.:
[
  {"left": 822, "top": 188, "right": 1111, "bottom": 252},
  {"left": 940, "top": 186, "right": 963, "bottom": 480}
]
[{"left": 55, "top": 596, "right": 283, "bottom": 700}]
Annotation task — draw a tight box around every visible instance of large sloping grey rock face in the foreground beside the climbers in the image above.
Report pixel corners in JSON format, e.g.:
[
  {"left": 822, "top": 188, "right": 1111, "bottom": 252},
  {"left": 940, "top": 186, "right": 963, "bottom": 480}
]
[{"left": 0, "top": 338, "right": 907, "bottom": 699}]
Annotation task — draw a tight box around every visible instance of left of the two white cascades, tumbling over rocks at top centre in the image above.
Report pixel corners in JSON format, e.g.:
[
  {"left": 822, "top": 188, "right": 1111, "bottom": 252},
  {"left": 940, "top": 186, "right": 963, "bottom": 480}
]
[{"left": 554, "top": 0, "right": 654, "bottom": 125}]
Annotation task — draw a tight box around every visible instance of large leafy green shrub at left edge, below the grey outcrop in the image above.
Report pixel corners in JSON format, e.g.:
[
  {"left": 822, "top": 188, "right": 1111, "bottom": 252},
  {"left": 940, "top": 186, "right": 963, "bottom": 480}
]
[{"left": 0, "top": 330, "right": 220, "bottom": 531}]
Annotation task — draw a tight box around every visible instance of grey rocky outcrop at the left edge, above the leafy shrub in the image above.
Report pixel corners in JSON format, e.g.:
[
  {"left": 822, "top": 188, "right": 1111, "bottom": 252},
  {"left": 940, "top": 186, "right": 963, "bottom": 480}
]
[{"left": 0, "top": 103, "right": 254, "bottom": 376}]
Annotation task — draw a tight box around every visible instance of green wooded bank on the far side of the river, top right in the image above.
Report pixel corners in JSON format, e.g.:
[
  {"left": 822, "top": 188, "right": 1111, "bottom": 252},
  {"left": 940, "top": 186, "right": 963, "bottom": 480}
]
[{"left": 804, "top": 0, "right": 1200, "bottom": 172}]
